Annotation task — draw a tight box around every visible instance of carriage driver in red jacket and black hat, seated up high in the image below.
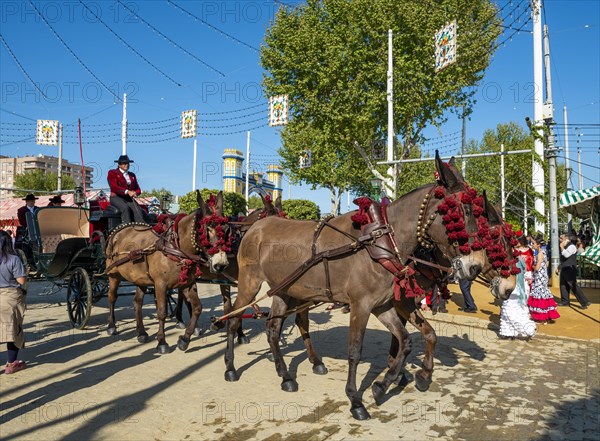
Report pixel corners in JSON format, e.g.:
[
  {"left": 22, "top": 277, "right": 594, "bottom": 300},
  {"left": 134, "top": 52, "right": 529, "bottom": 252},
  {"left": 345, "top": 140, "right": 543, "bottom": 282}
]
[{"left": 107, "top": 155, "right": 145, "bottom": 223}]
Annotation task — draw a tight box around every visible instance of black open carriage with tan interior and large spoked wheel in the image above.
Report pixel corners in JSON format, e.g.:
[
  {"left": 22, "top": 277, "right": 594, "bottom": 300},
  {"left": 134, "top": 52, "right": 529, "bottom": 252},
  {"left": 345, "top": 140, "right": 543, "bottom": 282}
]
[{"left": 16, "top": 200, "right": 176, "bottom": 329}]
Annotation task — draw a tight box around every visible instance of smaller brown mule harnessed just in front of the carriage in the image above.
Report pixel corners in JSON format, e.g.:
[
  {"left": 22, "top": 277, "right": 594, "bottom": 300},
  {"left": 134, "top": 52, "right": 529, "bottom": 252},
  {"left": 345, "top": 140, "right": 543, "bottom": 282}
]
[{"left": 105, "top": 191, "right": 230, "bottom": 354}]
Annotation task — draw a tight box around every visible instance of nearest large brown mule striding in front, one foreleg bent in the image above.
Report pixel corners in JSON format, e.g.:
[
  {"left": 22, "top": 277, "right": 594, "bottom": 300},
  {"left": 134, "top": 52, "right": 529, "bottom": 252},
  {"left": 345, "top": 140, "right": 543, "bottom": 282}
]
[{"left": 225, "top": 153, "right": 496, "bottom": 419}]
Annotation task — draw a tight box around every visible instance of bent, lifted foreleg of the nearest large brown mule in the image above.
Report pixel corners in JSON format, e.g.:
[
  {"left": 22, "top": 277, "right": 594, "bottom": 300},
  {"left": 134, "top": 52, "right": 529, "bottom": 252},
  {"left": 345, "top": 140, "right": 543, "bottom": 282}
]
[{"left": 371, "top": 304, "right": 412, "bottom": 406}]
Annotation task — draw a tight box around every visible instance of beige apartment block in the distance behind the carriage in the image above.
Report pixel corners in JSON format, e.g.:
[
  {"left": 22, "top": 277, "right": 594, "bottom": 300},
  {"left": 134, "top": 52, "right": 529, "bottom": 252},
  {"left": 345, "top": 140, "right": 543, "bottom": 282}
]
[{"left": 0, "top": 154, "right": 94, "bottom": 199}]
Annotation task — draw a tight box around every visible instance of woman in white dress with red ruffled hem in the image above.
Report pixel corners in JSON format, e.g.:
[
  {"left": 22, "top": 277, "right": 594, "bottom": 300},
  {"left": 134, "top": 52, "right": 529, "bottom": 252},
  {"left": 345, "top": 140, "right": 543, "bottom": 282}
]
[{"left": 527, "top": 236, "right": 560, "bottom": 324}]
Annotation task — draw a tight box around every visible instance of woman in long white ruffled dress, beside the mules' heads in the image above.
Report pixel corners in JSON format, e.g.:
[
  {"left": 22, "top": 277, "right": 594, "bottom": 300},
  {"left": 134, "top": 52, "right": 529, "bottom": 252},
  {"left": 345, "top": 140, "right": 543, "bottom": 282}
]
[{"left": 499, "top": 242, "right": 536, "bottom": 339}]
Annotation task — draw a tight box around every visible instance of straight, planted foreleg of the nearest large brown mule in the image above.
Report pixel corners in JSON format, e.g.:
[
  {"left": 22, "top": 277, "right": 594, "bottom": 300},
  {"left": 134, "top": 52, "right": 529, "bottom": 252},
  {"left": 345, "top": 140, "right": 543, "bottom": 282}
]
[{"left": 346, "top": 301, "right": 371, "bottom": 420}]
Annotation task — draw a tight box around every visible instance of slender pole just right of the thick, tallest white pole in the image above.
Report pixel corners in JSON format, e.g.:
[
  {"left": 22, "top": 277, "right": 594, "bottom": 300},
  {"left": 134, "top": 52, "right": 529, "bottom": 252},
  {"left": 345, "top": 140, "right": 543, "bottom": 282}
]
[{"left": 544, "top": 25, "right": 560, "bottom": 286}]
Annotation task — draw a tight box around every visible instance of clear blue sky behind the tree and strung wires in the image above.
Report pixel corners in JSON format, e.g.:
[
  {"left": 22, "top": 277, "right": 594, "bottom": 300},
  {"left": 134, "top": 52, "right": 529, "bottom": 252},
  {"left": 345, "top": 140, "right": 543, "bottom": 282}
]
[{"left": 0, "top": 0, "right": 600, "bottom": 212}]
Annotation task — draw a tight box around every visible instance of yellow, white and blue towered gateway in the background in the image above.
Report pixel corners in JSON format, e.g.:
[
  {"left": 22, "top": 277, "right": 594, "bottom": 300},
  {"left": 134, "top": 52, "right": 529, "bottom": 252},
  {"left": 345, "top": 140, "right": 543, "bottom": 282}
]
[{"left": 223, "top": 149, "right": 283, "bottom": 200}]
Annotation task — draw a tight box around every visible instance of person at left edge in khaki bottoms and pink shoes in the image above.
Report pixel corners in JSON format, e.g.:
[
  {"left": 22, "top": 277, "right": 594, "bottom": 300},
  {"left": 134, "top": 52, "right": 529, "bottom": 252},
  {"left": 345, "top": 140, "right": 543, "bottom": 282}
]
[{"left": 0, "top": 230, "right": 27, "bottom": 374}]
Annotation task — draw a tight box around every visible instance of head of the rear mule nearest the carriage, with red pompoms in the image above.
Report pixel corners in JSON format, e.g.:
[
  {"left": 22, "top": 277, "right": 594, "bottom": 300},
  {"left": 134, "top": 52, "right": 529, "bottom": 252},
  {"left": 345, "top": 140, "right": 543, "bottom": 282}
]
[{"left": 192, "top": 190, "right": 232, "bottom": 273}]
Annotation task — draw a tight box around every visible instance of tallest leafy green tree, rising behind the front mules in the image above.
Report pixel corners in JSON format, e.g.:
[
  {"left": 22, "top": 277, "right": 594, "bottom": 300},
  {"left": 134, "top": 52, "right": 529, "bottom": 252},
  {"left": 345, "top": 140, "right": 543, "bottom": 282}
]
[{"left": 261, "top": 0, "right": 501, "bottom": 209}]
